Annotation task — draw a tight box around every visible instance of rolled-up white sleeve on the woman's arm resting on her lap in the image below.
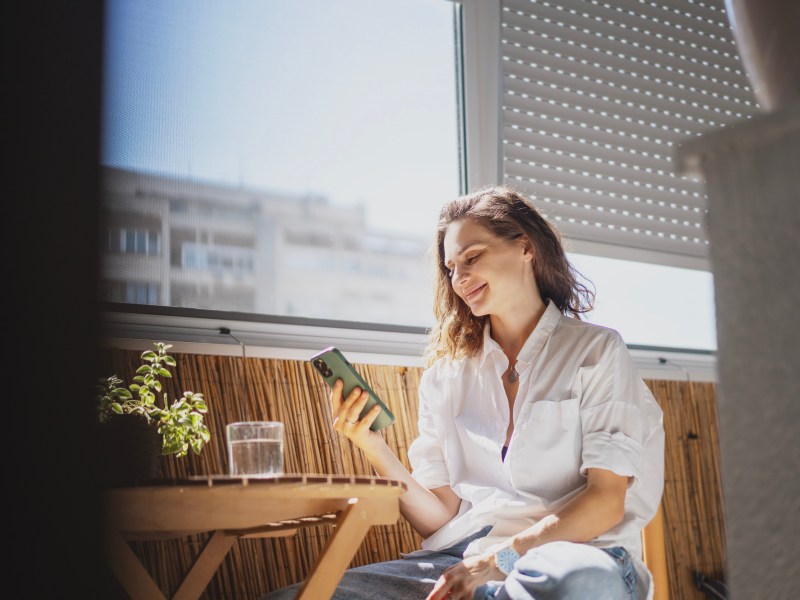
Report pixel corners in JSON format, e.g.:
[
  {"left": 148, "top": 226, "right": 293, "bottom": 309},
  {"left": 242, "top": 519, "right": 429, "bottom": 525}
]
[{"left": 580, "top": 334, "right": 652, "bottom": 484}]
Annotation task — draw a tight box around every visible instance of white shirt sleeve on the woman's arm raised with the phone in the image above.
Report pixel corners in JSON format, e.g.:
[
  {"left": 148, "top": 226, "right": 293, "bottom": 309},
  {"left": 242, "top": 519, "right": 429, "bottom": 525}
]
[{"left": 408, "top": 369, "right": 450, "bottom": 489}]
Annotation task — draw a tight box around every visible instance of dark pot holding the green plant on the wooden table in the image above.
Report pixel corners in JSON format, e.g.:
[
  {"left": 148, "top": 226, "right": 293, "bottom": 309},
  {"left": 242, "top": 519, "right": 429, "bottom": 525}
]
[{"left": 97, "top": 414, "right": 162, "bottom": 488}]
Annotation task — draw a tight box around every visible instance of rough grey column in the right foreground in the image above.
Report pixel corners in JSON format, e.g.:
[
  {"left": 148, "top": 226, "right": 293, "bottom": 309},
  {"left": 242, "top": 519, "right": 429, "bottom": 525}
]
[{"left": 676, "top": 103, "right": 800, "bottom": 600}]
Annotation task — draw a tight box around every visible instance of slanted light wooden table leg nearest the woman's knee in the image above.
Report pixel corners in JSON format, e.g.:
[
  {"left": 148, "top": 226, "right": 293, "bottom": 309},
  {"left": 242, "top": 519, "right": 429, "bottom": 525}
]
[{"left": 297, "top": 499, "right": 379, "bottom": 600}]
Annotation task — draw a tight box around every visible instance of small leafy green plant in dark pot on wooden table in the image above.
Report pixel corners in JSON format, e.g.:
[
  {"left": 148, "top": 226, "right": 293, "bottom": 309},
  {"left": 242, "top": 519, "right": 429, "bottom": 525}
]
[{"left": 96, "top": 342, "right": 211, "bottom": 484}]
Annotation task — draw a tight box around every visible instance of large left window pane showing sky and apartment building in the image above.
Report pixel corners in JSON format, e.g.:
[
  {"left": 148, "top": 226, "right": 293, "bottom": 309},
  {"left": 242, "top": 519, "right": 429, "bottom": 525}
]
[{"left": 100, "top": 0, "right": 459, "bottom": 326}]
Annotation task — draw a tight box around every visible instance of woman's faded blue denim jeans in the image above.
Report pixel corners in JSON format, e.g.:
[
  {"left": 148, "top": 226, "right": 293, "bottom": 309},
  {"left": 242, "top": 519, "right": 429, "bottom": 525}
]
[{"left": 262, "top": 527, "right": 637, "bottom": 600}]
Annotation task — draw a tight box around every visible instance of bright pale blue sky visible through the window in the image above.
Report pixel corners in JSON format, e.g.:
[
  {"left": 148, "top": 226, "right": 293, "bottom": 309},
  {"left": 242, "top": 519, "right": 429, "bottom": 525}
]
[{"left": 102, "top": 0, "right": 716, "bottom": 349}]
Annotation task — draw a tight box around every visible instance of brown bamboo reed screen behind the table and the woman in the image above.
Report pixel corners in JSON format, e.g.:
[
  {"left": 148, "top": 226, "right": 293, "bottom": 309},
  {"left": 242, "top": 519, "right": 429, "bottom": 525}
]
[{"left": 98, "top": 349, "right": 725, "bottom": 600}]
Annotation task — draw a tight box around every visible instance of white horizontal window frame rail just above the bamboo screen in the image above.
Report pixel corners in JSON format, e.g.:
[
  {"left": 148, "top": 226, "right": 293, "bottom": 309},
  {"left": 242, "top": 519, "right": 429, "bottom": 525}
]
[{"left": 102, "top": 305, "right": 717, "bottom": 382}]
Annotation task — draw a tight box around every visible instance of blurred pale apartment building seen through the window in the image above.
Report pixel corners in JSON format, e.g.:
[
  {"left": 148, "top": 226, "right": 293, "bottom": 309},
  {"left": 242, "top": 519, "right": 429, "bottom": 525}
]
[{"left": 100, "top": 167, "right": 433, "bottom": 326}]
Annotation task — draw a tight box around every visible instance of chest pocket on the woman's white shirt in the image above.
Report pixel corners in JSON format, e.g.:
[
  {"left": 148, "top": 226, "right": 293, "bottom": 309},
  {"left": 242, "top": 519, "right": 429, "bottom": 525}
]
[{"left": 509, "top": 398, "right": 584, "bottom": 501}]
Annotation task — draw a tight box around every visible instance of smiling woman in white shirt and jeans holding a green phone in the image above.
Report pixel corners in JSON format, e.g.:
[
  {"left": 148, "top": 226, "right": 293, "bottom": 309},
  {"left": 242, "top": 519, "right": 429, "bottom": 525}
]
[{"left": 269, "top": 187, "right": 664, "bottom": 600}]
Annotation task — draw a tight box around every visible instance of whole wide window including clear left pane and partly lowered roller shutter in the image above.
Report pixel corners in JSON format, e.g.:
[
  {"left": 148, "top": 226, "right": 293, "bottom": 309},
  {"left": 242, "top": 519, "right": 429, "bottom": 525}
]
[{"left": 102, "top": 0, "right": 740, "bottom": 360}]
